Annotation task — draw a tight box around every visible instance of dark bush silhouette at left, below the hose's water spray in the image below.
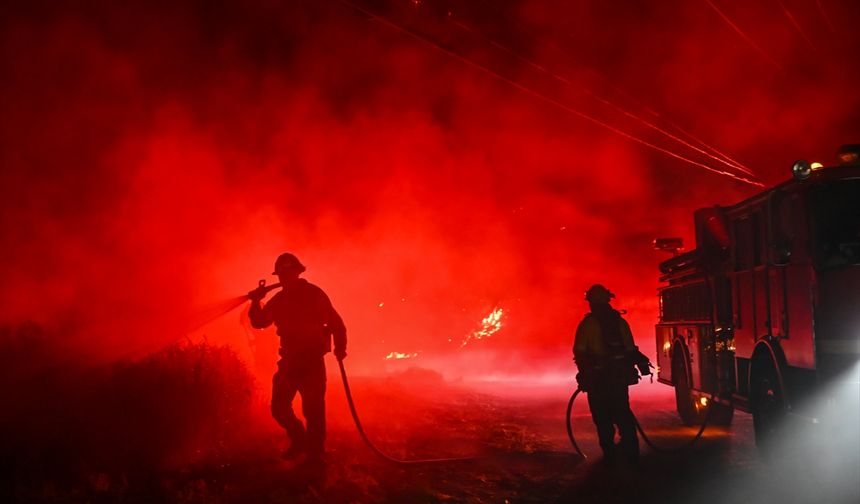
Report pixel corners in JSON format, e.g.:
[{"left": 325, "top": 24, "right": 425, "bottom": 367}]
[{"left": 0, "top": 324, "right": 255, "bottom": 496}]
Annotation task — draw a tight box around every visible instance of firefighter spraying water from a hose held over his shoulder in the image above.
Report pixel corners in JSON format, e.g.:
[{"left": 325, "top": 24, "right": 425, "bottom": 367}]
[{"left": 248, "top": 253, "right": 346, "bottom": 462}]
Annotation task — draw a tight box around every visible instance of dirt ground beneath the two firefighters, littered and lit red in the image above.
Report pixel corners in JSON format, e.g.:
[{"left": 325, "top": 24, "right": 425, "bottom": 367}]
[{"left": 158, "top": 372, "right": 860, "bottom": 504}]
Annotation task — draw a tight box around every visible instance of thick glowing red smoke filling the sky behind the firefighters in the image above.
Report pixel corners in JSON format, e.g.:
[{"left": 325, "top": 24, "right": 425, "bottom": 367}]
[{"left": 0, "top": 0, "right": 860, "bottom": 378}]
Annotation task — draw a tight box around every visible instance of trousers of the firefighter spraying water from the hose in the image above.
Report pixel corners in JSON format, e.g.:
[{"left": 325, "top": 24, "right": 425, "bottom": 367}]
[{"left": 272, "top": 356, "right": 326, "bottom": 456}]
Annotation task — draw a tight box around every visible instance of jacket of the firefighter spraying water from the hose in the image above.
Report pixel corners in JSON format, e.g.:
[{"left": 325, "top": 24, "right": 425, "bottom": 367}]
[{"left": 248, "top": 278, "right": 346, "bottom": 357}]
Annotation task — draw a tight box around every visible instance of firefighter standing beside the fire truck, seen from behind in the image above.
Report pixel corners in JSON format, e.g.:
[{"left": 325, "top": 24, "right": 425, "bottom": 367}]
[{"left": 573, "top": 284, "right": 649, "bottom": 463}]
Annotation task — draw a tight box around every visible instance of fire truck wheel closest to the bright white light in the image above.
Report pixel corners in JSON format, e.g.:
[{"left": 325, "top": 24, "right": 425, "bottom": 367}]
[{"left": 750, "top": 359, "right": 786, "bottom": 457}]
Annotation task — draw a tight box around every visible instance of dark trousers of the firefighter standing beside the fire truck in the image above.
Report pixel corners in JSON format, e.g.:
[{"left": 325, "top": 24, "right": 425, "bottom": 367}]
[{"left": 588, "top": 380, "right": 639, "bottom": 462}]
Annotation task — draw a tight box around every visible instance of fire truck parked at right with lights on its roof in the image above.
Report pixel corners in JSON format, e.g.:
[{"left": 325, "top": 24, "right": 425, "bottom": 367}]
[{"left": 655, "top": 145, "right": 860, "bottom": 446}]
